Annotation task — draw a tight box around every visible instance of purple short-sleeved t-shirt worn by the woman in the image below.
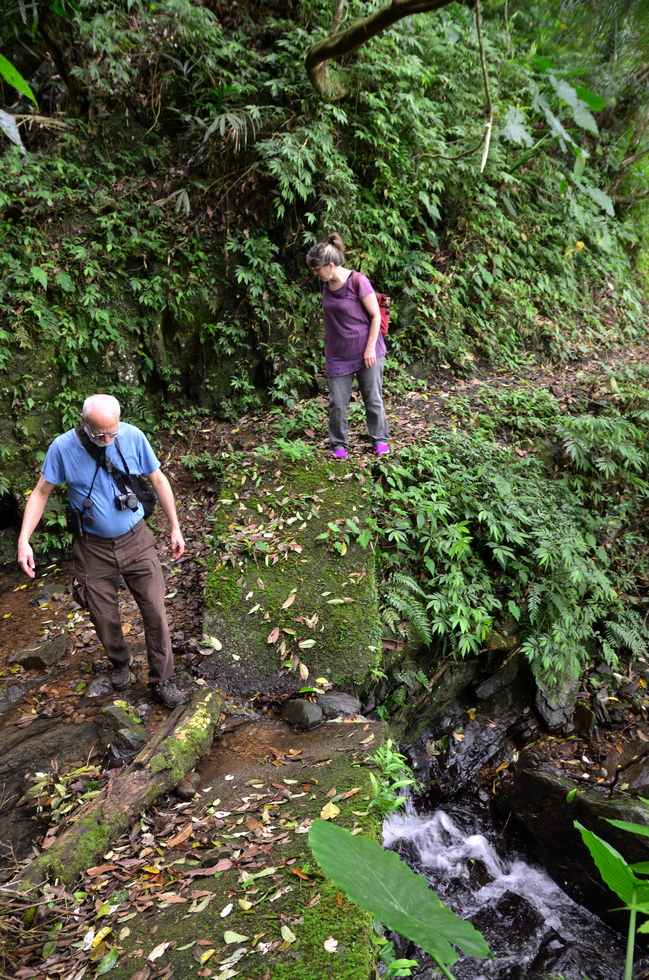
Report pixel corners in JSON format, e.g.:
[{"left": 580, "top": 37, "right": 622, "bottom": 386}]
[{"left": 322, "top": 273, "right": 385, "bottom": 378}]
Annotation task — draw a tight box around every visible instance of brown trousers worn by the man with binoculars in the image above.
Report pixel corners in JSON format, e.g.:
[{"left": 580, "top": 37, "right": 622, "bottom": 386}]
[{"left": 72, "top": 520, "right": 174, "bottom": 684}]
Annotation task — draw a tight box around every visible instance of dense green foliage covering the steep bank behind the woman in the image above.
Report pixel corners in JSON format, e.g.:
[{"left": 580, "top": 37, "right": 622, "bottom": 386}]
[{"left": 0, "top": 0, "right": 644, "bottom": 464}]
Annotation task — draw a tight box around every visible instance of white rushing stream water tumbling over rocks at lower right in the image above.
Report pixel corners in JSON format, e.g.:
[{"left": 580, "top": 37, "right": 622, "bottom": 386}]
[{"left": 383, "top": 800, "right": 632, "bottom": 980}]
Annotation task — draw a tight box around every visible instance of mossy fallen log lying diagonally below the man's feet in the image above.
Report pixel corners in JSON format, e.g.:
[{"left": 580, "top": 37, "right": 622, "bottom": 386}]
[{"left": 10, "top": 691, "right": 223, "bottom": 891}]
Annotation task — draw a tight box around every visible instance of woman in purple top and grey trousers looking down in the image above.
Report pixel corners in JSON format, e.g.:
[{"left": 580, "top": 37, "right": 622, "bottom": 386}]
[{"left": 306, "top": 233, "right": 390, "bottom": 459}]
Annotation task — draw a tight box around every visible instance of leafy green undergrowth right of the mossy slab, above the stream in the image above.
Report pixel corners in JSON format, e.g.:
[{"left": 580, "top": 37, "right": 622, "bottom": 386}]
[{"left": 372, "top": 367, "right": 649, "bottom": 686}]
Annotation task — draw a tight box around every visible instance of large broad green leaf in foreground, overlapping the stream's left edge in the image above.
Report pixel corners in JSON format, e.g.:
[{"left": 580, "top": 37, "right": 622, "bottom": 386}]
[{"left": 309, "top": 820, "right": 489, "bottom": 966}]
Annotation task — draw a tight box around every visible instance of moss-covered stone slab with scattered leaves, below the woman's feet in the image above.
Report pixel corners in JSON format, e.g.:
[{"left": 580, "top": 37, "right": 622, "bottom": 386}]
[{"left": 204, "top": 461, "right": 381, "bottom": 695}]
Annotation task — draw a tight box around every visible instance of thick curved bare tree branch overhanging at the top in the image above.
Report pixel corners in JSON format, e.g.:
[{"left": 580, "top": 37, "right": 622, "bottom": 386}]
[{"left": 304, "top": 0, "right": 453, "bottom": 98}]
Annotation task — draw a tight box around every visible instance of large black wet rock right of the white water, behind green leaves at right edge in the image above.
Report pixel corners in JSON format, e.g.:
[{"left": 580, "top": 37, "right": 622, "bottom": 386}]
[{"left": 508, "top": 768, "right": 649, "bottom": 931}]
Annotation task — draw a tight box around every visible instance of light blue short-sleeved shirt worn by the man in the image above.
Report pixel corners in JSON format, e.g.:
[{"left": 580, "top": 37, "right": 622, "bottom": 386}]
[{"left": 41, "top": 422, "right": 160, "bottom": 538}]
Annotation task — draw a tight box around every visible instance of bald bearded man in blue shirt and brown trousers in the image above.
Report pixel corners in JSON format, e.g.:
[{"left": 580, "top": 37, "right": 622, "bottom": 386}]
[{"left": 18, "top": 395, "right": 185, "bottom": 708}]
